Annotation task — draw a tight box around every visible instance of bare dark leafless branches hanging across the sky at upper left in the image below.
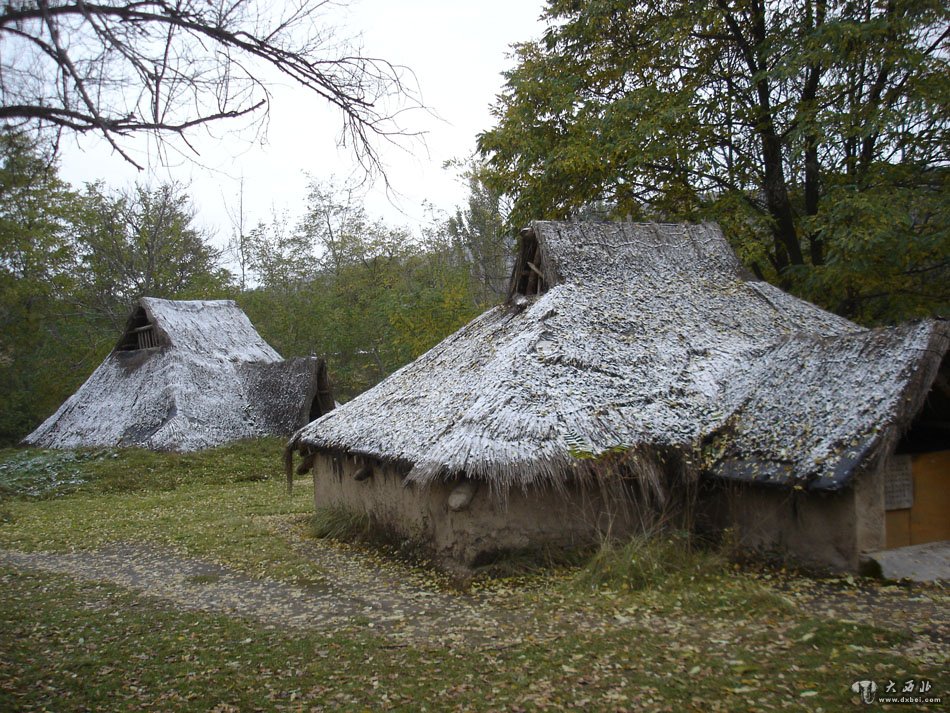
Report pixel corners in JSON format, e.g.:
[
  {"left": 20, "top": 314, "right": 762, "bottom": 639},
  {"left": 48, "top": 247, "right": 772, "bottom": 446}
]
[{"left": 0, "top": 0, "right": 421, "bottom": 170}]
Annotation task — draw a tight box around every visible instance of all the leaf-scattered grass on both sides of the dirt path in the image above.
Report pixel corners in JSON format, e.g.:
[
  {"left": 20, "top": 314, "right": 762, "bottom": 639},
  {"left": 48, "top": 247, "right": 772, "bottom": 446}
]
[{"left": 0, "top": 441, "right": 946, "bottom": 713}]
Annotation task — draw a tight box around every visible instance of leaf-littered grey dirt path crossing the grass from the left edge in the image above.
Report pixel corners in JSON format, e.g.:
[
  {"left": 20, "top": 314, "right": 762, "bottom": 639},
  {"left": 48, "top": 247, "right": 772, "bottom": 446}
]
[{"left": 0, "top": 543, "right": 563, "bottom": 645}]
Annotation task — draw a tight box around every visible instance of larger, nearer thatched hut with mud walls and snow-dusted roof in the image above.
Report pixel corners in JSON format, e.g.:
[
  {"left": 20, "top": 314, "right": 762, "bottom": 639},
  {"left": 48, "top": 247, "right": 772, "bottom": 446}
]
[{"left": 288, "top": 222, "right": 950, "bottom": 569}]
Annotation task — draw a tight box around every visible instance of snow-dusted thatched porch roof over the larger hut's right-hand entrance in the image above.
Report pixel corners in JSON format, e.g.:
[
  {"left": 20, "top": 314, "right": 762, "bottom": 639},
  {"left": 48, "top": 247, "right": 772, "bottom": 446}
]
[{"left": 712, "top": 321, "right": 950, "bottom": 490}]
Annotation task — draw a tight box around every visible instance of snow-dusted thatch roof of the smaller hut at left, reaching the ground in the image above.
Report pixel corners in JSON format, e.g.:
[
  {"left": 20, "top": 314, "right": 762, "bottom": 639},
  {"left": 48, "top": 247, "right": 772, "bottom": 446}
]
[{"left": 24, "top": 297, "right": 333, "bottom": 451}]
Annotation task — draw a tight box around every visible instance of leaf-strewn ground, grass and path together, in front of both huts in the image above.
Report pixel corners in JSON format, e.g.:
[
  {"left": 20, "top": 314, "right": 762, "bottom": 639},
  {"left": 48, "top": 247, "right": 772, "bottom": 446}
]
[{"left": 0, "top": 442, "right": 950, "bottom": 713}]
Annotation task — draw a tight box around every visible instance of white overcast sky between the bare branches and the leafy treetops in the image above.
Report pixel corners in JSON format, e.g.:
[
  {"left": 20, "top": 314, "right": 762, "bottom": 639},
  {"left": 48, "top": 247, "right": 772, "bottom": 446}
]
[{"left": 61, "top": 0, "right": 544, "bottom": 245}]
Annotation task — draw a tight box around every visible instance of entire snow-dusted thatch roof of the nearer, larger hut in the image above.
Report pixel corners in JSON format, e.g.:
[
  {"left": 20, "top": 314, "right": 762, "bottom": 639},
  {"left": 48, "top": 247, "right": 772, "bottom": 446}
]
[{"left": 291, "top": 222, "right": 950, "bottom": 491}]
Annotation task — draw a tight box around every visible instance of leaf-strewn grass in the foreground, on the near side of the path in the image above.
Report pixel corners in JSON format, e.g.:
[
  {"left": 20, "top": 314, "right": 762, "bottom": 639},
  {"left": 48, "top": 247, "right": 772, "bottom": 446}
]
[{"left": 0, "top": 571, "right": 939, "bottom": 711}]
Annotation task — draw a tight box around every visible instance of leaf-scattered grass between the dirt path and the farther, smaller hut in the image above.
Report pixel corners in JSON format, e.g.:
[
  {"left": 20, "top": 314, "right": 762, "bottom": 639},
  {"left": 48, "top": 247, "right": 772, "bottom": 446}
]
[{"left": 0, "top": 439, "right": 323, "bottom": 582}]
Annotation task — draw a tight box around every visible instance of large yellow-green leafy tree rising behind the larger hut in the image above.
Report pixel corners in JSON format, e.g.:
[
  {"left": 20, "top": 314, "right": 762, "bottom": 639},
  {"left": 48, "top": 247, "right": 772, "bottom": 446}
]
[{"left": 479, "top": 0, "right": 950, "bottom": 321}]
